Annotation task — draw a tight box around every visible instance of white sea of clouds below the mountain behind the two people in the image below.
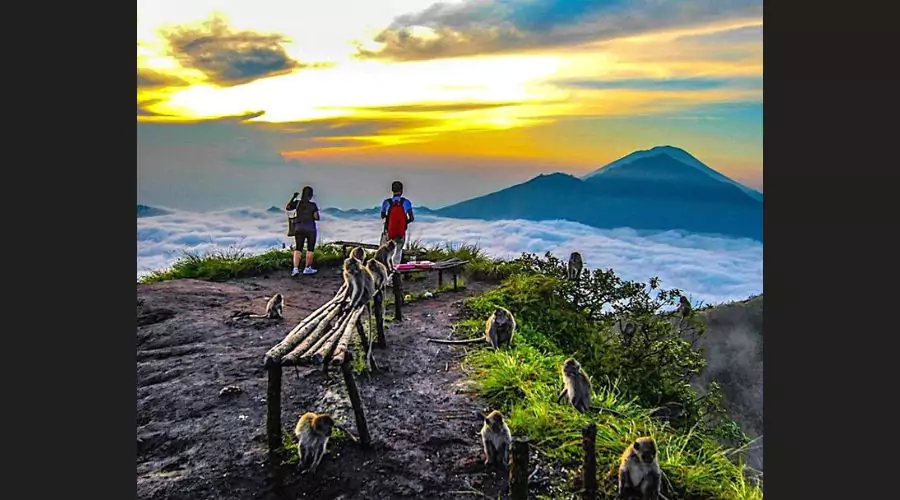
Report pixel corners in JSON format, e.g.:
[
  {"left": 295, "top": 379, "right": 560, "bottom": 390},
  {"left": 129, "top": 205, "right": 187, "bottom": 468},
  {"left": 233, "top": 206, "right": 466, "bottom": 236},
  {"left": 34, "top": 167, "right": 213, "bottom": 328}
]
[{"left": 137, "top": 208, "right": 763, "bottom": 304}]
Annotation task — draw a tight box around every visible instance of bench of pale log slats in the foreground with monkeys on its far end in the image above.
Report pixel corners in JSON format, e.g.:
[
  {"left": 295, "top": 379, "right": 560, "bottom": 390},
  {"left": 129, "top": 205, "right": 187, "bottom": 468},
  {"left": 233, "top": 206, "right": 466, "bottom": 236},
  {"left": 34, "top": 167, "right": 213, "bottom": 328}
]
[{"left": 264, "top": 284, "right": 387, "bottom": 454}]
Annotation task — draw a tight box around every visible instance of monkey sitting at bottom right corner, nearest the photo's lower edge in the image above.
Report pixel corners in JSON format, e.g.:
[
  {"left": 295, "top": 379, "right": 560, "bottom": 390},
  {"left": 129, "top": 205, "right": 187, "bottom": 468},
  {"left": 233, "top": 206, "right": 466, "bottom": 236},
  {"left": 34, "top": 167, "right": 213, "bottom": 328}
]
[{"left": 616, "top": 436, "right": 662, "bottom": 500}]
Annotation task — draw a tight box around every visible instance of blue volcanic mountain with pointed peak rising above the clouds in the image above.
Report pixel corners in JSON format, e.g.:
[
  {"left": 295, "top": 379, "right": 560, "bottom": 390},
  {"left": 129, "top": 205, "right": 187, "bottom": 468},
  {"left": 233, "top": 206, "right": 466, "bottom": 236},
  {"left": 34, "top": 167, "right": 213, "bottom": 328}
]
[{"left": 435, "top": 146, "right": 763, "bottom": 241}]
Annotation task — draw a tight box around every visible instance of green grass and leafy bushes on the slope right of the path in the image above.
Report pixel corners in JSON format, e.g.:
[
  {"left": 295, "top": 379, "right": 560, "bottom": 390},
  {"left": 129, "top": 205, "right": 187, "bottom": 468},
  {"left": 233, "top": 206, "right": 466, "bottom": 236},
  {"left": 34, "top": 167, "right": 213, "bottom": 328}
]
[{"left": 458, "top": 253, "right": 762, "bottom": 500}]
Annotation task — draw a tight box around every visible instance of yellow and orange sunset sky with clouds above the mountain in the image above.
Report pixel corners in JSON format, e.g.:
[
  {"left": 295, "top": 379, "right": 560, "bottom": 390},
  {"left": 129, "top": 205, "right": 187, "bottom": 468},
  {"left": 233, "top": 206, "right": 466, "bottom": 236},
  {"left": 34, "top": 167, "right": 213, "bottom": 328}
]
[{"left": 137, "top": 0, "right": 763, "bottom": 209}]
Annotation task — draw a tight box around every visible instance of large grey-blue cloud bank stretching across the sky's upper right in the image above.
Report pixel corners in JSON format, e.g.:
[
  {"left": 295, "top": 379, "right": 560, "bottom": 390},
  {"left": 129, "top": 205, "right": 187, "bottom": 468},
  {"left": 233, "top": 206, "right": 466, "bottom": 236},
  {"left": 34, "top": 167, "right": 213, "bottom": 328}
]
[{"left": 357, "top": 0, "right": 763, "bottom": 60}]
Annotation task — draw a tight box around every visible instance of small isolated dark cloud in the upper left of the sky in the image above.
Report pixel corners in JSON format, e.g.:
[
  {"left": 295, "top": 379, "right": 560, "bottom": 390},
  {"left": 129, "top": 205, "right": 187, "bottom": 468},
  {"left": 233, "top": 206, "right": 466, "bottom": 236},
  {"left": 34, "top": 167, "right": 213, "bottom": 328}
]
[{"left": 162, "top": 17, "right": 322, "bottom": 86}]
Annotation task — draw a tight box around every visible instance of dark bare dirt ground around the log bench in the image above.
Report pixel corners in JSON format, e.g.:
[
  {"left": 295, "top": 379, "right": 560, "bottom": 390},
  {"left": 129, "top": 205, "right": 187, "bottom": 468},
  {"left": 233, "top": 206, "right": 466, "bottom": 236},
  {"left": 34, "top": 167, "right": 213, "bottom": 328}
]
[{"left": 137, "top": 269, "right": 516, "bottom": 500}]
